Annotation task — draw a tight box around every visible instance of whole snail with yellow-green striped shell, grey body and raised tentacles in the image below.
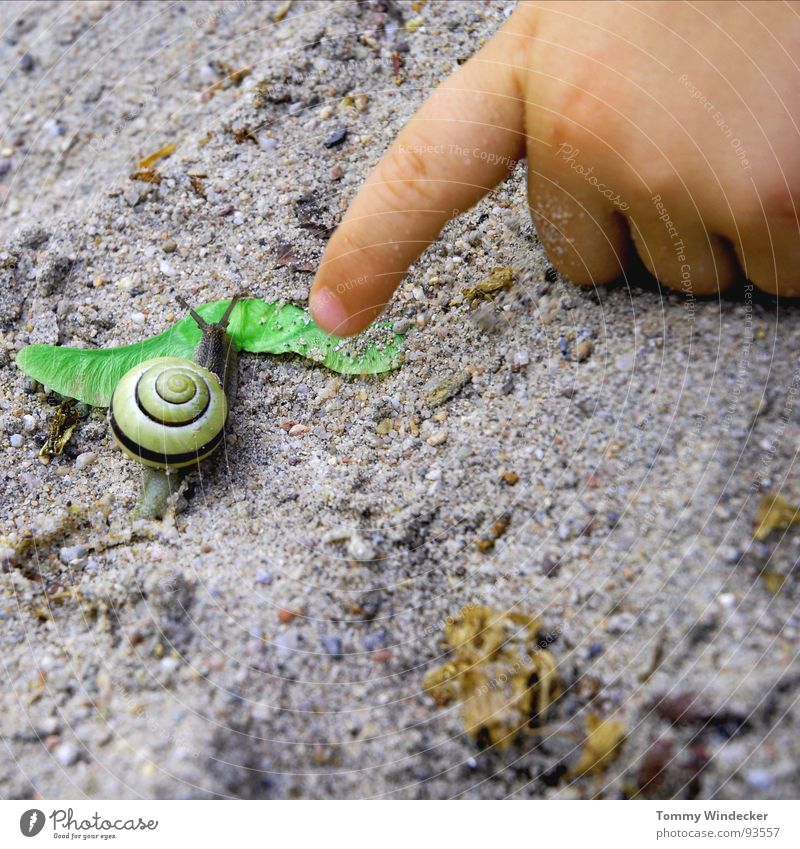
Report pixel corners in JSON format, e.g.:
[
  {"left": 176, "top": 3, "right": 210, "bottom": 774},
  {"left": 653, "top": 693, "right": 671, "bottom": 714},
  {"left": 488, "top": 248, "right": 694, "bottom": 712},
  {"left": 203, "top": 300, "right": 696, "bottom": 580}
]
[{"left": 108, "top": 295, "right": 239, "bottom": 519}]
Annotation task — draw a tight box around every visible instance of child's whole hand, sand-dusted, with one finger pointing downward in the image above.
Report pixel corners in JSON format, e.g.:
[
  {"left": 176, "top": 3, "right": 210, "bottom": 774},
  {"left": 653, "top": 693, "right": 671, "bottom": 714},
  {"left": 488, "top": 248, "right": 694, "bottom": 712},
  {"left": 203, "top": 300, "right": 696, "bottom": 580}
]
[{"left": 311, "top": 2, "right": 800, "bottom": 335}]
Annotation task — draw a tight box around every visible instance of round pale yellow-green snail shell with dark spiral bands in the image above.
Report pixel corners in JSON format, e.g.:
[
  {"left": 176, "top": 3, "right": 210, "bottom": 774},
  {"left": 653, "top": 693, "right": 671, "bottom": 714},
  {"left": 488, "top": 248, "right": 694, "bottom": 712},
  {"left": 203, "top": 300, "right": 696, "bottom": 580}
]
[{"left": 108, "top": 357, "right": 228, "bottom": 469}]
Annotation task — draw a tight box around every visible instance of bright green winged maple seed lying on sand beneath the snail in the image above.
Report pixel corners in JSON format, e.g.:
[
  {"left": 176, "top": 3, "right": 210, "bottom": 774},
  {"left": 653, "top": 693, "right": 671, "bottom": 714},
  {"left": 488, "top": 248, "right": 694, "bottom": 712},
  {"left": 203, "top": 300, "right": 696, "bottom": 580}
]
[{"left": 17, "top": 298, "right": 403, "bottom": 407}]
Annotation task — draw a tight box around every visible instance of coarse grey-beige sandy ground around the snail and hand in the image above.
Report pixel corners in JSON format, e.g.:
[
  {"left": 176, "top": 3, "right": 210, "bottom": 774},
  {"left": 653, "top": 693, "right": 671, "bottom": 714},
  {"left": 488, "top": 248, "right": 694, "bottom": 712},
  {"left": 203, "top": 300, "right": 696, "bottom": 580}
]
[{"left": 0, "top": 0, "right": 800, "bottom": 799}]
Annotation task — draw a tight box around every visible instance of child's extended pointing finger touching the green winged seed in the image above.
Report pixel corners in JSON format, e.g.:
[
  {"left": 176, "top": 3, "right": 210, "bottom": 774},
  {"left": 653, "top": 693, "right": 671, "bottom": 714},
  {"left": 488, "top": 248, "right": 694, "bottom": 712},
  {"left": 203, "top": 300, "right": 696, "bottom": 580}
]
[{"left": 310, "top": 25, "right": 525, "bottom": 336}]
